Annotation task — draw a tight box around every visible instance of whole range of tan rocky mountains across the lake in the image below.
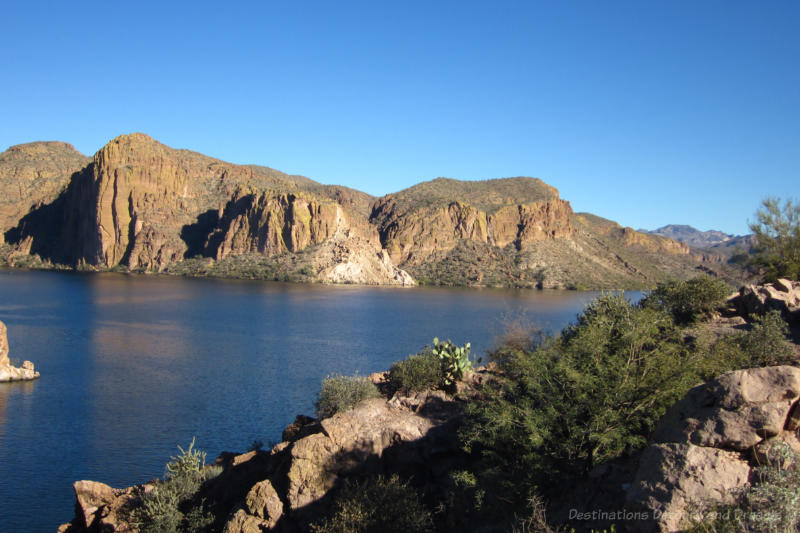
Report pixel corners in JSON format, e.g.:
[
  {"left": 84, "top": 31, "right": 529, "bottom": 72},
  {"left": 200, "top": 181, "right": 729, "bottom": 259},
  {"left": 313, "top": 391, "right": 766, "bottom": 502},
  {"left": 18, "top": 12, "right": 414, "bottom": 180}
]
[{"left": 0, "top": 133, "right": 729, "bottom": 289}]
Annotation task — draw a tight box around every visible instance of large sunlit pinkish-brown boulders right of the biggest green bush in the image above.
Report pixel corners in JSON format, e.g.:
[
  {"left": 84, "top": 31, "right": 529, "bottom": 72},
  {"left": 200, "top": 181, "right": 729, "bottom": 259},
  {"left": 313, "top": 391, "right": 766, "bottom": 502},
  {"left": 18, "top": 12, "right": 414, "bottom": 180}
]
[{"left": 627, "top": 366, "right": 800, "bottom": 531}]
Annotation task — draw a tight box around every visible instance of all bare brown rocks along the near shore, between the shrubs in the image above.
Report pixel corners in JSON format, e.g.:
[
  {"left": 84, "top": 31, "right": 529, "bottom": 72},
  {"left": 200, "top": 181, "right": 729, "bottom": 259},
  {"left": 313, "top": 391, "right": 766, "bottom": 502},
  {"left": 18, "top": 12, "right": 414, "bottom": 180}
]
[{"left": 54, "top": 280, "right": 800, "bottom": 533}]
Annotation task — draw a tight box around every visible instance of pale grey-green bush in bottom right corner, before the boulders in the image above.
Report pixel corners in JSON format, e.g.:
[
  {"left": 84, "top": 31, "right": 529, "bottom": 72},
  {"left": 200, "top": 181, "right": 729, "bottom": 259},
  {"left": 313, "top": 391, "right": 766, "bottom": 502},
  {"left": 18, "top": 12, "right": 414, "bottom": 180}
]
[{"left": 688, "top": 442, "right": 800, "bottom": 533}]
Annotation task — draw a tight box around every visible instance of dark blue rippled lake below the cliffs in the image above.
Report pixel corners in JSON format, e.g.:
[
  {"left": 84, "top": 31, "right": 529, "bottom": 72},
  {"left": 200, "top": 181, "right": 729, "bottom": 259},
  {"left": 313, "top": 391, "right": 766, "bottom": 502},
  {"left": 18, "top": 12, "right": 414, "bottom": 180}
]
[{"left": 0, "top": 271, "right": 624, "bottom": 532}]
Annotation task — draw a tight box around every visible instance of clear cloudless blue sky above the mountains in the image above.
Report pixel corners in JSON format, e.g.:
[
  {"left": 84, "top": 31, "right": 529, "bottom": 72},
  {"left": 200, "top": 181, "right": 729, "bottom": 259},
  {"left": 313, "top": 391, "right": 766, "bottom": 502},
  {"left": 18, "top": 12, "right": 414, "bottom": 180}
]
[{"left": 0, "top": 0, "right": 800, "bottom": 233}]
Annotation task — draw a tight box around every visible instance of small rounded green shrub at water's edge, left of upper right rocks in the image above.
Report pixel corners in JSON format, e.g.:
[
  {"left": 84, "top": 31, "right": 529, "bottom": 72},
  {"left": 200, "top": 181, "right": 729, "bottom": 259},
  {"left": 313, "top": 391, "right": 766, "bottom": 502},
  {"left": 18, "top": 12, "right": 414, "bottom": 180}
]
[{"left": 642, "top": 276, "right": 731, "bottom": 324}]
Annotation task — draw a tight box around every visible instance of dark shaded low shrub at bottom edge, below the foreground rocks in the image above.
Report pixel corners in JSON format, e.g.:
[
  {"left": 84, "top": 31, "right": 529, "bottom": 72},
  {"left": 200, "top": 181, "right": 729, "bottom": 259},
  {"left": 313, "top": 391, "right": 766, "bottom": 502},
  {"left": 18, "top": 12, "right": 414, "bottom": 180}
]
[{"left": 311, "top": 475, "right": 433, "bottom": 533}]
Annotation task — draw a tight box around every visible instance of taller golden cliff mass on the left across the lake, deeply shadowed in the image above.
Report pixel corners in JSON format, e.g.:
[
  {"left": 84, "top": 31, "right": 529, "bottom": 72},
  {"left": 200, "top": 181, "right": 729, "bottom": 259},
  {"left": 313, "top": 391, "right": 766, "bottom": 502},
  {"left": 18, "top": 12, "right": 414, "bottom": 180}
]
[{"left": 1, "top": 134, "right": 413, "bottom": 284}]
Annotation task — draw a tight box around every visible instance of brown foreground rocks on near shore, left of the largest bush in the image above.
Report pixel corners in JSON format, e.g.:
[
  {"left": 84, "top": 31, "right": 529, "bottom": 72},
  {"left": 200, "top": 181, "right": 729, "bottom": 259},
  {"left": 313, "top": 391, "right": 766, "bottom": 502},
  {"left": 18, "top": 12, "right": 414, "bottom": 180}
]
[{"left": 59, "top": 391, "right": 462, "bottom": 533}]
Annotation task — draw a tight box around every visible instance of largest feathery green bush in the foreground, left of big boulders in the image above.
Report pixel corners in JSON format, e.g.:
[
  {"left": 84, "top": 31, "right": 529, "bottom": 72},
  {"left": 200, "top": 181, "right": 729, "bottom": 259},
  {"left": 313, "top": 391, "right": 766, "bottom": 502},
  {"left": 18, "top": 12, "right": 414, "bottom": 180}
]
[{"left": 460, "top": 295, "right": 698, "bottom": 508}]
